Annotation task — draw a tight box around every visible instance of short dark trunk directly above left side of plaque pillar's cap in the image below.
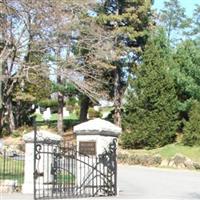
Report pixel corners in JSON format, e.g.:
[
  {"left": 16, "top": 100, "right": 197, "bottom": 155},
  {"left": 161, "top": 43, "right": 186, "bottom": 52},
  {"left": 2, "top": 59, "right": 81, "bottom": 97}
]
[{"left": 80, "top": 95, "right": 90, "bottom": 122}]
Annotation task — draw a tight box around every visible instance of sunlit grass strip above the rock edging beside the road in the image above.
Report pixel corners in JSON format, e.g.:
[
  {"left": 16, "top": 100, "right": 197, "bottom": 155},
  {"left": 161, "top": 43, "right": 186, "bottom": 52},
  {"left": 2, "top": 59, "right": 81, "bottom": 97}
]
[{"left": 120, "top": 144, "right": 200, "bottom": 162}]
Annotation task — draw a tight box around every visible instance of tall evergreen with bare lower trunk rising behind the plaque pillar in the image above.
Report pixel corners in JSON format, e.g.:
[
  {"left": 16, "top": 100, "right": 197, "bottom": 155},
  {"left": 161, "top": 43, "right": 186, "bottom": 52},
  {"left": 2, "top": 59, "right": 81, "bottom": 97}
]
[{"left": 98, "top": 0, "right": 152, "bottom": 126}]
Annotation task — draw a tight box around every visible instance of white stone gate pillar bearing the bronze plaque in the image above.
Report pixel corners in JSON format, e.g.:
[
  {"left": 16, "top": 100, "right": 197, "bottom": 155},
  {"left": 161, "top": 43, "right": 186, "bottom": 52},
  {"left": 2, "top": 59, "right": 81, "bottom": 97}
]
[{"left": 74, "top": 118, "right": 121, "bottom": 195}]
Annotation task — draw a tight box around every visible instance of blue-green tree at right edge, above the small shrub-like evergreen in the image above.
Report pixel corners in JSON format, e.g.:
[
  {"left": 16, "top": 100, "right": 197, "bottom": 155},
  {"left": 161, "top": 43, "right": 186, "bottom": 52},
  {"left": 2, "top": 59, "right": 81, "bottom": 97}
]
[{"left": 171, "top": 40, "right": 200, "bottom": 120}]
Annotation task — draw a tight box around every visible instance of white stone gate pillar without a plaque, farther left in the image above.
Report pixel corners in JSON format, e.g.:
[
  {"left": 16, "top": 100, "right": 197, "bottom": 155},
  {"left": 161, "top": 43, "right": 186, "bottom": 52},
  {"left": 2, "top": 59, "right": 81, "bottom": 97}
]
[{"left": 22, "top": 130, "right": 62, "bottom": 194}]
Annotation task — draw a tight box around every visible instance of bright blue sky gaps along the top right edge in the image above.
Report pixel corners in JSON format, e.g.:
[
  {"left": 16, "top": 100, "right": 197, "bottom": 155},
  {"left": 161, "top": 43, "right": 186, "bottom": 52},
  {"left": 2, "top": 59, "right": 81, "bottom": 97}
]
[{"left": 154, "top": 0, "right": 200, "bottom": 17}]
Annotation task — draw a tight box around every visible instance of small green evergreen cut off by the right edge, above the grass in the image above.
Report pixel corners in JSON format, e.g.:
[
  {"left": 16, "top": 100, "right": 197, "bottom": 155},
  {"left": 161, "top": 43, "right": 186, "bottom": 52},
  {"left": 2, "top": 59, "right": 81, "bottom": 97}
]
[{"left": 182, "top": 101, "right": 200, "bottom": 146}]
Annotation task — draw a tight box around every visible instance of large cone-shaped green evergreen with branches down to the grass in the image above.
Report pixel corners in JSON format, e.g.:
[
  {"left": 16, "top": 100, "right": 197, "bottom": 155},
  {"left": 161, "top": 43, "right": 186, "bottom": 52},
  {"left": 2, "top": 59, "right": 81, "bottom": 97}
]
[{"left": 121, "top": 29, "right": 177, "bottom": 148}]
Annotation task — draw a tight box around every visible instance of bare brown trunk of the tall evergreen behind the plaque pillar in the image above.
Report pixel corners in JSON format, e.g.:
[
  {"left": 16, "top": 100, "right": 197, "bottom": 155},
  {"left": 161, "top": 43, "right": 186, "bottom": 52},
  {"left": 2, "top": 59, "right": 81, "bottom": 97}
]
[{"left": 114, "top": 67, "right": 123, "bottom": 127}]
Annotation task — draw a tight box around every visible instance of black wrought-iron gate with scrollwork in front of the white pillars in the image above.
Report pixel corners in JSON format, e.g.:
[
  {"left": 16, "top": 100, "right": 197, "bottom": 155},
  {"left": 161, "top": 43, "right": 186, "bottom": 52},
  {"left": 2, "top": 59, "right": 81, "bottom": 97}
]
[{"left": 34, "top": 131, "right": 117, "bottom": 199}]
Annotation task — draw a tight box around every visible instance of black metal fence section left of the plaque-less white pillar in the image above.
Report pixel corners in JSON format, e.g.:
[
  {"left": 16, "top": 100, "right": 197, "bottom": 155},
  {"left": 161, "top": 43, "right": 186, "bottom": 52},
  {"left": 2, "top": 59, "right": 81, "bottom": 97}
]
[{"left": 0, "top": 150, "right": 24, "bottom": 192}]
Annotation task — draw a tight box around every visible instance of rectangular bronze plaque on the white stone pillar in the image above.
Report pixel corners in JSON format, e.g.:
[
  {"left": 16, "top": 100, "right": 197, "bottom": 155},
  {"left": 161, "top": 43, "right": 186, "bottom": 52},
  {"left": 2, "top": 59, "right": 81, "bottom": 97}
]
[{"left": 79, "top": 142, "right": 96, "bottom": 156}]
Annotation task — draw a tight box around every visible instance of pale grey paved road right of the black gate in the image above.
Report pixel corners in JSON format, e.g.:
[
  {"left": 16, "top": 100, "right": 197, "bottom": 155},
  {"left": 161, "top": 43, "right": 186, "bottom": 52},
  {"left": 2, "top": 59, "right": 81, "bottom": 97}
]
[{"left": 118, "top": 166, "right": 200, "bottom": 199}]
